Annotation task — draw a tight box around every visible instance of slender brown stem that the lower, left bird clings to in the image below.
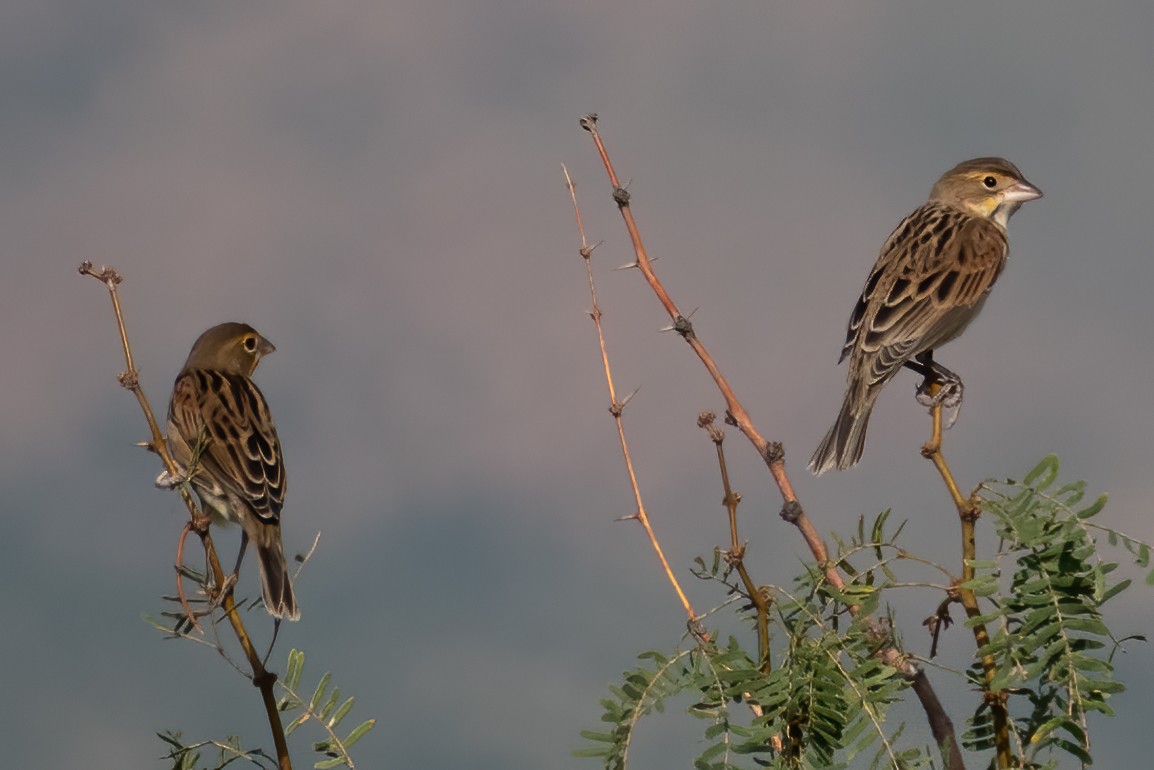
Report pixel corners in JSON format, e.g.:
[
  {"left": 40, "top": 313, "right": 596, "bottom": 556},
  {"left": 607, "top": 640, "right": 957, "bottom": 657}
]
[{"left": 80, "top": 261, "right": 292, "bottom": 770}]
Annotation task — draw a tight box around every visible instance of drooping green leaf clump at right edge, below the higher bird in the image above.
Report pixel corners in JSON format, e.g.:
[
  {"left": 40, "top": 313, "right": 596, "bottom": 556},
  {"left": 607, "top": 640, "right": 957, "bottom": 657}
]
[{"left": 967, "top": 455, "right": 1148, "bottom": 764}]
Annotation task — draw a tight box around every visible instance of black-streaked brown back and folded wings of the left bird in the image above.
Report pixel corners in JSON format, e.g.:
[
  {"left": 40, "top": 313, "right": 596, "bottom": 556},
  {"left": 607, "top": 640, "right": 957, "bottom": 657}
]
[{"left": 168, "top": 369, "right": 285, "bottom": 522}]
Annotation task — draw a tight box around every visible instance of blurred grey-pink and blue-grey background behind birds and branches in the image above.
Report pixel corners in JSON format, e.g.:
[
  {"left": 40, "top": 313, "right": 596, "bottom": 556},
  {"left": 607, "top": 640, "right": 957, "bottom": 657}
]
[{"left": 0, "top": 0, "right": 1154, "bottom": 770}]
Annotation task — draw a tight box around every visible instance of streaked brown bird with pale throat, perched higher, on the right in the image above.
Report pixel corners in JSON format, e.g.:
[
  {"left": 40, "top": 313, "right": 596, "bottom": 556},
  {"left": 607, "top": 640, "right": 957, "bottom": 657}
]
[{"left": 809, "top": 158, "right": 1042, "bottom": 476}]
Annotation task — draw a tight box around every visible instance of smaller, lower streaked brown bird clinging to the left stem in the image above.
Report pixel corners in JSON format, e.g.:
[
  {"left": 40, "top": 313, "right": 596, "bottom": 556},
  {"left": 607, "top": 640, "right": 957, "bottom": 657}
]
[{"left": 168, "top": 323, "right": 300, "bottom": 620}]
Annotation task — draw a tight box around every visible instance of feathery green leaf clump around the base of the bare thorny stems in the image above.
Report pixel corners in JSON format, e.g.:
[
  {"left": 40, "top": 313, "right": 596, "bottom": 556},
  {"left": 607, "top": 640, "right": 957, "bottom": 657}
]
[{"left": 575, "top": 517, "right": 929, "bottom": 770}]
